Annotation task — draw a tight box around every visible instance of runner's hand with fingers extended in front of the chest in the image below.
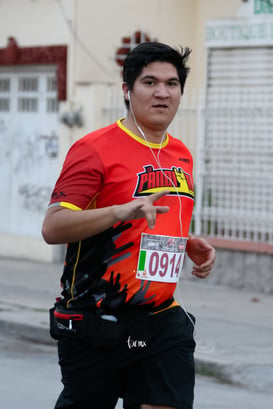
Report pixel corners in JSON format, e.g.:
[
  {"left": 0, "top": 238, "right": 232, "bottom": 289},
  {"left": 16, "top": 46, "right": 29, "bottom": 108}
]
[{"left": 114, "top": 190, "right": 169, "bottom": 229}]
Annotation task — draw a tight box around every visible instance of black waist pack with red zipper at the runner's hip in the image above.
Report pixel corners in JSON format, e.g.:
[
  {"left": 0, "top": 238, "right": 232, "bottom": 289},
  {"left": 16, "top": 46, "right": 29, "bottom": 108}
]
[{"left": 49, "top": 303, "right": 126, "bottom": 347}]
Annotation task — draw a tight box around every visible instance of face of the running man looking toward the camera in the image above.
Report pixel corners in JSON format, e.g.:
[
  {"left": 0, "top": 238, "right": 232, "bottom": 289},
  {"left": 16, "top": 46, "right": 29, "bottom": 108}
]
[{"left": 124, "top": 61, "right": 181, "bottom": 132}]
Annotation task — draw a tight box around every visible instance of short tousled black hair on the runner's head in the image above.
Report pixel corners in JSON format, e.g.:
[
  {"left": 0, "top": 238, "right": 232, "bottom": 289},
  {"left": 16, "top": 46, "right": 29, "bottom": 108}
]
[{"left": 123, "top": 41, "right": 191, "bottom": 105}]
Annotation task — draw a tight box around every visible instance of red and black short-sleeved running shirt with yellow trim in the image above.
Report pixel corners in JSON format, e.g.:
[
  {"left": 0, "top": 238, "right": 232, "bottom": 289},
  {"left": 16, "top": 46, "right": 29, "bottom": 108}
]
[{"left": 50, "top": 120, "right": 194, "bottom": 310}]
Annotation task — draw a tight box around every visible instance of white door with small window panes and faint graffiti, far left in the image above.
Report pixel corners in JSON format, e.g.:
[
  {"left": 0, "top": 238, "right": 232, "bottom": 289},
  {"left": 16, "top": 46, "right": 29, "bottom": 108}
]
[{"left": 0, "top": 66, "right": 58, "bottom": 238}]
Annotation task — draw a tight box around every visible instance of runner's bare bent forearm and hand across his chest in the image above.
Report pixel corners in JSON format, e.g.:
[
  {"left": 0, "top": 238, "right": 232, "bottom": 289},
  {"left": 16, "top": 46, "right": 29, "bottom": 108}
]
[{"left": 42, "top": 190, "right": 169, "bottom": 244}]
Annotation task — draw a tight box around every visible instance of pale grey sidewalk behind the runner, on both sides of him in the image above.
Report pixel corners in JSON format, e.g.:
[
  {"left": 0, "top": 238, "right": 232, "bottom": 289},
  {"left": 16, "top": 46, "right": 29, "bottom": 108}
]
[{"left": 0, "top": 258, "right": 273, "bottom": 393}]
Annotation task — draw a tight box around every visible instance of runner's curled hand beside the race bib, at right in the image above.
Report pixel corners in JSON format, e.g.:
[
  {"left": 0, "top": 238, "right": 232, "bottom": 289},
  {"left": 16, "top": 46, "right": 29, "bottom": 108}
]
[{"left": 186, "top": 234, "right": 216, "bottom": 278}]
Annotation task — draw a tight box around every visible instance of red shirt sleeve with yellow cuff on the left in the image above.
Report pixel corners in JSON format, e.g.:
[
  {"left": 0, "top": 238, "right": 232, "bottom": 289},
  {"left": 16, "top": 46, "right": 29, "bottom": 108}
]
[{"left": 49, "top": 138, "right": 104, "bottom": 210}]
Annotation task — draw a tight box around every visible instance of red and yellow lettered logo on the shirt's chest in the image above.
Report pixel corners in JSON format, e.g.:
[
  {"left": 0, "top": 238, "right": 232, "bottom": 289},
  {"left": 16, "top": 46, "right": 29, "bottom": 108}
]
[{"left": 134, "top": 165, "right": 194, "bottom": 198}]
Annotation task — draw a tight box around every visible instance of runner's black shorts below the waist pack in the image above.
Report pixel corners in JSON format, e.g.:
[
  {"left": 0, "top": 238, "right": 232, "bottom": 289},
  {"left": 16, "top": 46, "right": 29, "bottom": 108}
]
[{"left": 55, "top": 307, "right": 195, "bottom": 409}]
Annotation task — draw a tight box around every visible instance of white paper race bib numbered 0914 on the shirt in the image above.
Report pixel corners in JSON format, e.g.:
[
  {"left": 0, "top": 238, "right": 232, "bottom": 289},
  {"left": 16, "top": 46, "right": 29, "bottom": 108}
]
[{"left": 136, "top": 233, "right": 187, "bottom": 283}]
